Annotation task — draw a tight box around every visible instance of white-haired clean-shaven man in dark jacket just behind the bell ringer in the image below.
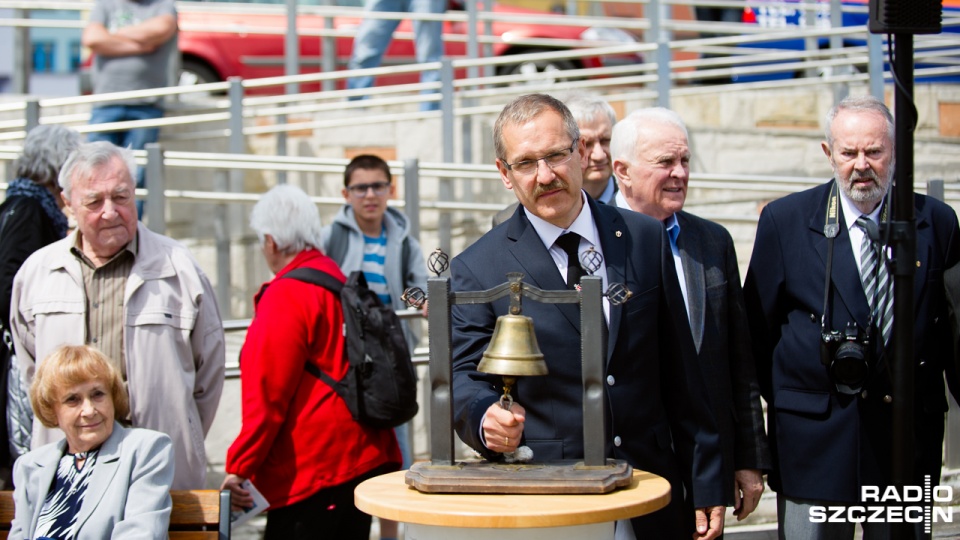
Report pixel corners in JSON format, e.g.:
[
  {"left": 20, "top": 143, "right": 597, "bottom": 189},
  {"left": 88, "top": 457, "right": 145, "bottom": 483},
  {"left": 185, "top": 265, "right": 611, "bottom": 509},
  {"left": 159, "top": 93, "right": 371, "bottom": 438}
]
[{"left": 610, "top": 107, "right": 770, "bottom": 520}]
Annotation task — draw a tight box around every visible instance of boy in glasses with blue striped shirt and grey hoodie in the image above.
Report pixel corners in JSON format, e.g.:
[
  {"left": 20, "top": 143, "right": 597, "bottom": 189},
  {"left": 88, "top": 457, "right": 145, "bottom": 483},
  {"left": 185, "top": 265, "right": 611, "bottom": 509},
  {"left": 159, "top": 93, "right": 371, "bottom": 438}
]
[{"left": 321, "top": 154, "right": 427, "bottom": 540}]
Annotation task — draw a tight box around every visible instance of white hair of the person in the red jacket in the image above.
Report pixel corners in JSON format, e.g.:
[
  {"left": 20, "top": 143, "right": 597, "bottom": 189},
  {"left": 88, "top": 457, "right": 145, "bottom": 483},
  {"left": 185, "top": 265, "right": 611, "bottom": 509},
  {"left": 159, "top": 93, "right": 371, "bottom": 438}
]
[{"left": 250, "top": 184, "right": 321, "bottom": 255}]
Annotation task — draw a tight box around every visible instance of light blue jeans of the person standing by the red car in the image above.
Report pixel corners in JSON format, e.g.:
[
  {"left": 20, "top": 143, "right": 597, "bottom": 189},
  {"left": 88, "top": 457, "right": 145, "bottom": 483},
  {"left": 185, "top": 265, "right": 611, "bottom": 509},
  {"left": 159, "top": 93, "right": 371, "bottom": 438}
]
[{"left": 347, "top": 0, "right": 446, "bottom": 111}]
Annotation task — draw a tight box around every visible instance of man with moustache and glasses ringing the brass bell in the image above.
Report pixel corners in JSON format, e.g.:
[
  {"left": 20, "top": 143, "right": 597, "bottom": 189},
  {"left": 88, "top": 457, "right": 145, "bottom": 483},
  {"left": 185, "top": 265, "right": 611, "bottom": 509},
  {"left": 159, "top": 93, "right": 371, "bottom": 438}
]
[{"left": 451, "top": 94, "right": 726, "bottom": 539}]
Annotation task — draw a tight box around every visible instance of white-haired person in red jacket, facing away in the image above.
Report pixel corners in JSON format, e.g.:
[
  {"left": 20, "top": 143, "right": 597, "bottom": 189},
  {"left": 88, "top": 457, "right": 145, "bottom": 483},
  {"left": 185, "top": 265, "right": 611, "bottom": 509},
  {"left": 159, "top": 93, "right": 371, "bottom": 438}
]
[{"left": 221, "top": 185, "right": 400, "bottom": 540}]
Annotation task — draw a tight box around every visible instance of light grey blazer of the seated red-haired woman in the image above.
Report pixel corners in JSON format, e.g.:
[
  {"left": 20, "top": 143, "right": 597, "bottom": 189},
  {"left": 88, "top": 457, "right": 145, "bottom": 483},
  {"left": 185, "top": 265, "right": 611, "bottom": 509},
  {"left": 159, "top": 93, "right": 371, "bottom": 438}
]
[{"left": 10, "top": 422, "right": 174, "bottom": 540}]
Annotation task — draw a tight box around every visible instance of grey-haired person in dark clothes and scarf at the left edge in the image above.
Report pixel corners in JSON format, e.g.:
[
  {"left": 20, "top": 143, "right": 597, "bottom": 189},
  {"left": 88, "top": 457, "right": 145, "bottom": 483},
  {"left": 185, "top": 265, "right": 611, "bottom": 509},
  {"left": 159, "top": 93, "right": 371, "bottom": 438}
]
[{"left": 0, "top": 124, "right": 81, "bottom": 481}]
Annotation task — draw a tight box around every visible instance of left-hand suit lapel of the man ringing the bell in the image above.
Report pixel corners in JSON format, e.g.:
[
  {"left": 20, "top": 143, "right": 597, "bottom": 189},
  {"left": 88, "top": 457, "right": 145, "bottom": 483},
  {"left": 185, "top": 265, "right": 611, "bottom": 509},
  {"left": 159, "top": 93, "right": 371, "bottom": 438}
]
[{"left": 502, "top": 210, "right": 580, "bottom": 333}]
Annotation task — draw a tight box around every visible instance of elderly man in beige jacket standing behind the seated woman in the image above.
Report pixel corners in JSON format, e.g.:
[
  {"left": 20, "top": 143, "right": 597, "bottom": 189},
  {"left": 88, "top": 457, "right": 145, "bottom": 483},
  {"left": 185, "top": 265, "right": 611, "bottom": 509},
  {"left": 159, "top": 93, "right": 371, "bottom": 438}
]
[{"left": 10, "top": 142, "right": 224, "bottom": 489}]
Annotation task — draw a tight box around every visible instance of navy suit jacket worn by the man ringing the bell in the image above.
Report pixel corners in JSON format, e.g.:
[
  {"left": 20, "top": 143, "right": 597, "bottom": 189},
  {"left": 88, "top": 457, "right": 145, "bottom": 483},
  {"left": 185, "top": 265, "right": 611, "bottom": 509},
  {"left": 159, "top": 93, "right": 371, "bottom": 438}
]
[{"left": 451, "top": 198, "right": 727, "bottom": 539}]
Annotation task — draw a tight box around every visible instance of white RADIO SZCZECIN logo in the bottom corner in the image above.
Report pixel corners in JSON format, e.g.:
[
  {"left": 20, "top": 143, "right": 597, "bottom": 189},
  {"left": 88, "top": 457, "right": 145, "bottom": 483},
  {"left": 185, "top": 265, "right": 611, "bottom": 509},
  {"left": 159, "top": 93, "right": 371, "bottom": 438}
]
[{"left": 810, "top": 475, "right": 953, "bottom": 533}]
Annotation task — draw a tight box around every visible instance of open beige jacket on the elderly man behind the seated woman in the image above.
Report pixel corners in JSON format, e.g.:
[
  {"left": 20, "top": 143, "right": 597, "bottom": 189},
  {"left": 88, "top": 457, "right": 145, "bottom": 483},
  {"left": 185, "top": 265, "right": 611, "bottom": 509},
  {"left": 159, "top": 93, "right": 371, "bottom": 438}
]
[{"left": 10, "top": 224, "right": 225, "bottom": 489}]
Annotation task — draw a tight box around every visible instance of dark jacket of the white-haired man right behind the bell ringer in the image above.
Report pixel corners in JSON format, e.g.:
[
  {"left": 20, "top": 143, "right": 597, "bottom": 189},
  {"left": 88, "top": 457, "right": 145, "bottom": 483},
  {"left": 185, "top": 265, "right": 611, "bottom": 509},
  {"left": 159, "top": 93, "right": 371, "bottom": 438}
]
[{"left": 677, "top": 212, "right": 771, "bottom": 504}]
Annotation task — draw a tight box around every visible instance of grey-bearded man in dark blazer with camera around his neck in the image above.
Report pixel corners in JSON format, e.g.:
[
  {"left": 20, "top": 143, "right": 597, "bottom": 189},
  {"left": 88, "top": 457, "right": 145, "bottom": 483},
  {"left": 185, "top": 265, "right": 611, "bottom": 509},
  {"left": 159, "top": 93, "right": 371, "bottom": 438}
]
[{"left": 744, "top": 97, "right": 960, "bottom": 538}]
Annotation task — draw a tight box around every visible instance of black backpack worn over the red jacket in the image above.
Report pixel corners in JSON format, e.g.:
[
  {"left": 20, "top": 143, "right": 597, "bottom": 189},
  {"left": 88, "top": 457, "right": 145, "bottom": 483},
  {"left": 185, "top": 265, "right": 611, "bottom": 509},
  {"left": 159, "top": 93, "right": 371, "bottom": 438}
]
[{"left": 283, "top": 268, "right": 418, "bottom": 428}]
